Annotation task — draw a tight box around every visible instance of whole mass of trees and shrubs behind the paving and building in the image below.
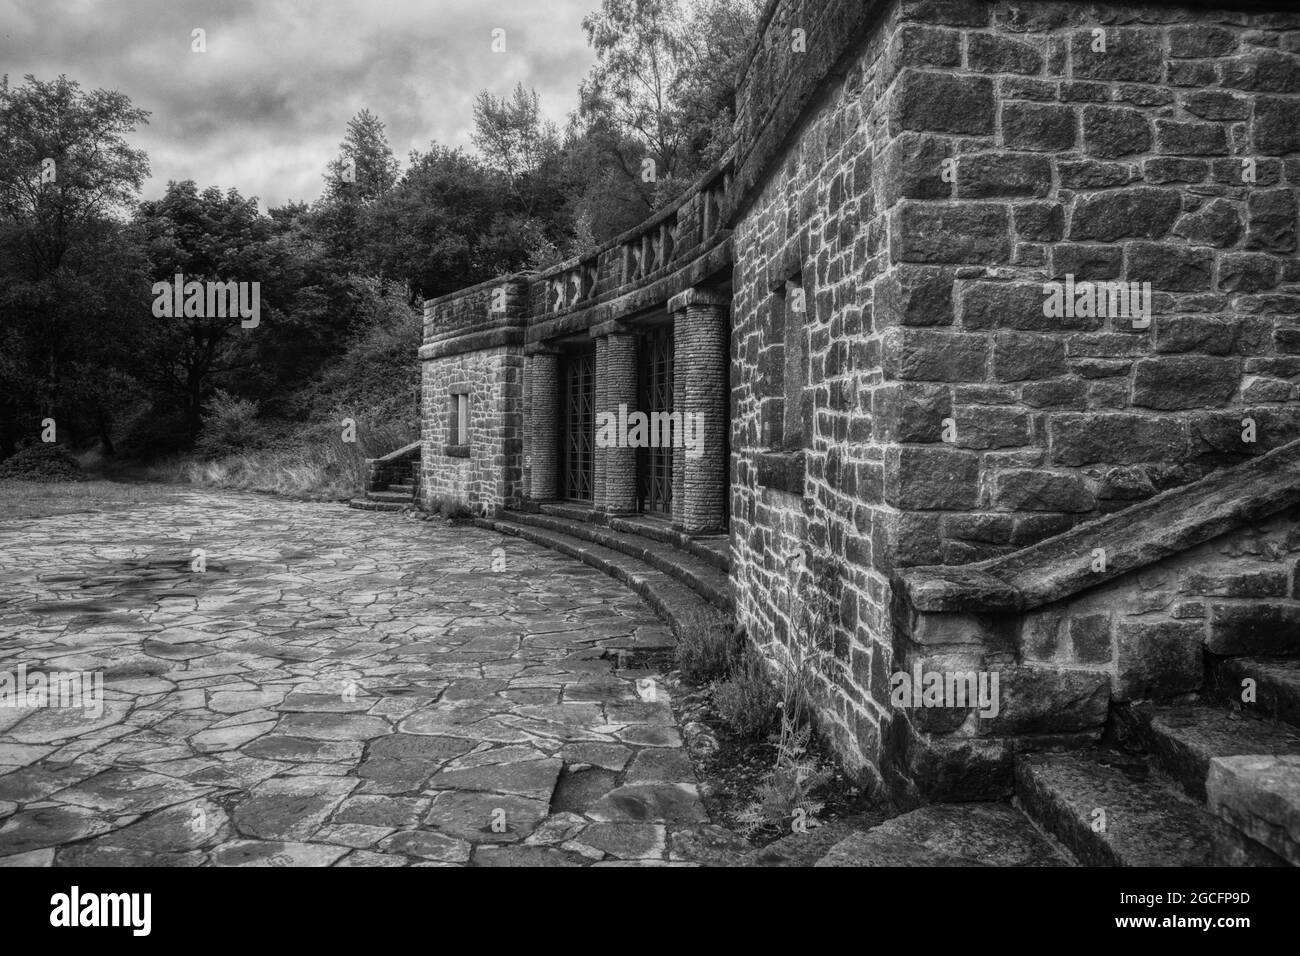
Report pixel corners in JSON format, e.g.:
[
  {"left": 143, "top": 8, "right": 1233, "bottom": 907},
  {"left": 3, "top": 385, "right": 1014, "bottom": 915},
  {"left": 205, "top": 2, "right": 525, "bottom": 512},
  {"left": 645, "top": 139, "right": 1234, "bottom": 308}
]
[{"left": 0, "top": 6, "right": 758, "bottom": 481}]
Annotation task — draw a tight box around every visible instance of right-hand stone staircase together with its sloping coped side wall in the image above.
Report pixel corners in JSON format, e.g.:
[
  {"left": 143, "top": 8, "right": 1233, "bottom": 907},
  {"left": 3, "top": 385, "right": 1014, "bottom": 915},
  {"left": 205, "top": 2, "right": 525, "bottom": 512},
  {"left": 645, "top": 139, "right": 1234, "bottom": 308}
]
[{"left": 745, "top": 442, "right": 1300, "bottom": 866}]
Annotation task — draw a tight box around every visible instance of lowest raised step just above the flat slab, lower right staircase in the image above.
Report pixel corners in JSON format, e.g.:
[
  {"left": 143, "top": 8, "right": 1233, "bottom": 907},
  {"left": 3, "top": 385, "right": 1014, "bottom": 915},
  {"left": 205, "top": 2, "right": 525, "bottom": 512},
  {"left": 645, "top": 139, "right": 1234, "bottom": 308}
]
[{"left": 1015, "top": 750, "right": 1286, "bottom": 866}]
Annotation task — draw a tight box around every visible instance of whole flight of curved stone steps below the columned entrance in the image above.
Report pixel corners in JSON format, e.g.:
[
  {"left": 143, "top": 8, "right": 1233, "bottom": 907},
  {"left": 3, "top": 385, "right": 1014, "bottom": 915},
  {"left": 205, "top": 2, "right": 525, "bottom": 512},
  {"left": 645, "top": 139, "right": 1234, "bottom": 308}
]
[{"left": 475, "top": 503, "right": 732, "bottom": 635}]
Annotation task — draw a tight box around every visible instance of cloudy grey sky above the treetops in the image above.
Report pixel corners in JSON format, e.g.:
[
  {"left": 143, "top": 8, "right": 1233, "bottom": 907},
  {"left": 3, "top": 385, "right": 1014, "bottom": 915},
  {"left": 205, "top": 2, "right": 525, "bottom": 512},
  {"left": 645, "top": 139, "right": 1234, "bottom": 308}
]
[{"left": 0, "top": 0, "right": 598, "bottom": 206}]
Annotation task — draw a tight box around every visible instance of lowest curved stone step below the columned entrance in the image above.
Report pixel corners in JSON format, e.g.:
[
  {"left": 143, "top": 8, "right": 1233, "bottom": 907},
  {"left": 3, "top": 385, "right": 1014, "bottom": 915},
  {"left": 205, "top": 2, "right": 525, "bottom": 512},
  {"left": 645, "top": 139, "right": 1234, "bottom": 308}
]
[{"left": 475, "top": 518, "right": 729, "bottom": 636}]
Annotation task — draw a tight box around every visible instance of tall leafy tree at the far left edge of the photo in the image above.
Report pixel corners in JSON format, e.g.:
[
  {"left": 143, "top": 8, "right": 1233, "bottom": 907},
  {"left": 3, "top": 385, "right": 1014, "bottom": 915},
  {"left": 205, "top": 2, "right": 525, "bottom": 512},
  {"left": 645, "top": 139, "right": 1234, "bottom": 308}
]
[{"left": 0, "top": 75, "right": 148, "bottom": 454}]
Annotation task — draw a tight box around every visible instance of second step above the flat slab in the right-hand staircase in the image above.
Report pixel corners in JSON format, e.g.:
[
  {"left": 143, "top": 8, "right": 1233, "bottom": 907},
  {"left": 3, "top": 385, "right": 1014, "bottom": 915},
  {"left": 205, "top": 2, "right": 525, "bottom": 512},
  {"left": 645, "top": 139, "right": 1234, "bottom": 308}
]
[{"left": 1115, "top": 705, "right": 1300, "bottom": 800}]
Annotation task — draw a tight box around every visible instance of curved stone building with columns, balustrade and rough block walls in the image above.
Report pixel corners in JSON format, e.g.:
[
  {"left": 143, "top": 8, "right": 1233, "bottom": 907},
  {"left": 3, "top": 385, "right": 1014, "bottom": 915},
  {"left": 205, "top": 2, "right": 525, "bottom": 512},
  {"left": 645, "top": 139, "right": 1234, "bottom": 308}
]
[{"left": 395, "top": 0, "right": 1300, "bottom": 860}]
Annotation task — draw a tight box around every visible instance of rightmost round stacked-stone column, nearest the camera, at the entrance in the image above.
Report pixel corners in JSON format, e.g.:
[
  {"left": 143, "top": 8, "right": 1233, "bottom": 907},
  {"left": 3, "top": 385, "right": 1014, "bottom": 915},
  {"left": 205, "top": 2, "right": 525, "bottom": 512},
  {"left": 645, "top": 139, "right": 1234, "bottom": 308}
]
[{"left": 668, "top": 289, "right": 729, "bottom": 535}]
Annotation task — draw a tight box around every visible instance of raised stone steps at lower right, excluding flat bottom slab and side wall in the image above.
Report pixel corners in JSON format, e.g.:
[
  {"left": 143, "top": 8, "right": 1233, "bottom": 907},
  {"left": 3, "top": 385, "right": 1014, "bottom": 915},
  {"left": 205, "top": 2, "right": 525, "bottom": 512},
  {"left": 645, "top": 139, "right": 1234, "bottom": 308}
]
[{"left": 1015, "top": 658, "right": 1300, "bottom": 866}]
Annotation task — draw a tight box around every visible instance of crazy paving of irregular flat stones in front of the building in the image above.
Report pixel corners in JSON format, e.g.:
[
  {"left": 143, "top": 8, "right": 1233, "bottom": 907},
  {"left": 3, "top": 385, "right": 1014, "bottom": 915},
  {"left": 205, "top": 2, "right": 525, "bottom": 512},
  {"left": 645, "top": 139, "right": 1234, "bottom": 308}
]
[{"left": 0, "top": 493, "right": 712, "bottom": 866}]
